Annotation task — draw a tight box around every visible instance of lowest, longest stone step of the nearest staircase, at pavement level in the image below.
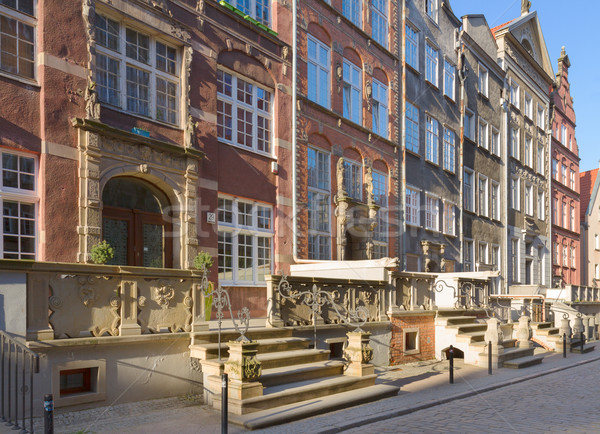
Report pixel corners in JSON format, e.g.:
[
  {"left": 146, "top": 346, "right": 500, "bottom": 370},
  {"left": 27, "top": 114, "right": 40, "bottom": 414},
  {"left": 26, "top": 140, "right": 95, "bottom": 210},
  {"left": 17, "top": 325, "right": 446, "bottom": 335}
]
[{"left": 229, "top": 384, "right": 400, "bottom": 430}]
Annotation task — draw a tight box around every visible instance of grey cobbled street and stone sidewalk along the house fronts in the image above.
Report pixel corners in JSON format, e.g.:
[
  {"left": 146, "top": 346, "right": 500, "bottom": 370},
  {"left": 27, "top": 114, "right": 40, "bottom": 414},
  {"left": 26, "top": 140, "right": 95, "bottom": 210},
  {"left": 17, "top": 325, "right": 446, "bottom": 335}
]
[{"left": 0, "top": 351, "right": 600, "bottom": 434}]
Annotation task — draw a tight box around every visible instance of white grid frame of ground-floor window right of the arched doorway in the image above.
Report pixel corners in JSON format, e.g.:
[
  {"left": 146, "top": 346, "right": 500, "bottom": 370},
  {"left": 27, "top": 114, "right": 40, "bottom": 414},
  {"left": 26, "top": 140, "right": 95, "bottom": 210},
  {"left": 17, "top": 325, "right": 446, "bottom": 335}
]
[{"left": 218, "top": 194, "right": 274, "bottom": 286}]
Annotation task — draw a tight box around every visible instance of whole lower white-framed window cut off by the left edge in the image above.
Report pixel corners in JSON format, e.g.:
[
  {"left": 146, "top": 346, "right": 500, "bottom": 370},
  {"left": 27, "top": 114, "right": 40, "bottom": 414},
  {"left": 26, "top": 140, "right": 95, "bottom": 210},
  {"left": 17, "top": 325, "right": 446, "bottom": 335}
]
[{"left": 0, "top": 152, "right": 37, "bottom": 259}]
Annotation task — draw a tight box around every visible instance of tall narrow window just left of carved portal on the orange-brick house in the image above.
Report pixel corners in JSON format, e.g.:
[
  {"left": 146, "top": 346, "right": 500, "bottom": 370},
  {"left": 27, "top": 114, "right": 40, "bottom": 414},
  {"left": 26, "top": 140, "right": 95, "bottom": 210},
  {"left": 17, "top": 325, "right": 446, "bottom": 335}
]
[{"left": 308, "top": 148, "right": 331, "bottom": 259}]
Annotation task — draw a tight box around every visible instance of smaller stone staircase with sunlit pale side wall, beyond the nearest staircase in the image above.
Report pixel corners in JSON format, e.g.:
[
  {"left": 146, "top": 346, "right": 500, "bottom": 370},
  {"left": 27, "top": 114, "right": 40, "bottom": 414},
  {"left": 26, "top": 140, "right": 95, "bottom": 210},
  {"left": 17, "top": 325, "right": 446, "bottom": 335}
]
[{"left": 435, "top": 310, "right": 542, "bottom": 368}]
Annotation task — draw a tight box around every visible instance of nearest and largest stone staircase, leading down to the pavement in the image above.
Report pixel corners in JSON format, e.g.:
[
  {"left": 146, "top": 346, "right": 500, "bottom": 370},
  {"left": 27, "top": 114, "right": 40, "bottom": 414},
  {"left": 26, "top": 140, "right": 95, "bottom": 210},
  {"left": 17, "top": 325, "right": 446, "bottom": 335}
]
[{"left": 190, "top": 328, "right": 399, "bottom": 429}]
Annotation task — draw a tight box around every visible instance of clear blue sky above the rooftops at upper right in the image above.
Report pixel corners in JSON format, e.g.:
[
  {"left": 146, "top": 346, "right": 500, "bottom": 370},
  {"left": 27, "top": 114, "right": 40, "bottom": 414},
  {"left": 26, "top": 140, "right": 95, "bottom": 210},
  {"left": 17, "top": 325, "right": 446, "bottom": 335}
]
[{"left": 450, "top": 0, "right": 600, "bottom": 172}]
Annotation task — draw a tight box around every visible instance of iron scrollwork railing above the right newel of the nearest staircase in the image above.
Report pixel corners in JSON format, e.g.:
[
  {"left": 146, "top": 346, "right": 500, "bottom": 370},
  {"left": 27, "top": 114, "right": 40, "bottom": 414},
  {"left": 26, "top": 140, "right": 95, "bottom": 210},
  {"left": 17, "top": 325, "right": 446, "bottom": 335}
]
[{"left": 277, "top": 274, "right": 369, "bottom": 348}]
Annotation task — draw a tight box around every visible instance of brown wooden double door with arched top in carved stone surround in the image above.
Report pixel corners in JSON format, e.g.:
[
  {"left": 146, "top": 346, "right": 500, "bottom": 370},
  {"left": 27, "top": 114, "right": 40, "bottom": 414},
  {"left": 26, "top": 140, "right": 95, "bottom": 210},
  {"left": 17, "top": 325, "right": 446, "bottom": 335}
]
[{"left": 102, "top": 177, "right": 173, "bottom": 268}]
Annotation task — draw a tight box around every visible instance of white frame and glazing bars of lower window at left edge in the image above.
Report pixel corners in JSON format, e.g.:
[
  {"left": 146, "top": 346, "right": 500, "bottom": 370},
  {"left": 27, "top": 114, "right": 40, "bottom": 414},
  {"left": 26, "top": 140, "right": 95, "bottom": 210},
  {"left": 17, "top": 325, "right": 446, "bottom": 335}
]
[{"left": 0, "top": 149, "right": 39, "bottom": 260}]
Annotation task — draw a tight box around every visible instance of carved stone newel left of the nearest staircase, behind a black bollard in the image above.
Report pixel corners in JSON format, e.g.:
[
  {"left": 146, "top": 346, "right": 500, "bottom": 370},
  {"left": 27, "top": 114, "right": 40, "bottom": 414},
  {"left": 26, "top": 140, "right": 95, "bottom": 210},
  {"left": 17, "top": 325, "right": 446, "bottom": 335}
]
[{"left": 225, "top": 340, "right": 263, "bottom": 399}]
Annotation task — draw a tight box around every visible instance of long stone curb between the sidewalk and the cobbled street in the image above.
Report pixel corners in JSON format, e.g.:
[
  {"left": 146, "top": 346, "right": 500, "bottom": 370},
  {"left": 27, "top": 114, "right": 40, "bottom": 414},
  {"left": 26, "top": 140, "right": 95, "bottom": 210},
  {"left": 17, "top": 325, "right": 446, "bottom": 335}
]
[{"left": 315, "top": 357, "right": 600, "bottom": 434}]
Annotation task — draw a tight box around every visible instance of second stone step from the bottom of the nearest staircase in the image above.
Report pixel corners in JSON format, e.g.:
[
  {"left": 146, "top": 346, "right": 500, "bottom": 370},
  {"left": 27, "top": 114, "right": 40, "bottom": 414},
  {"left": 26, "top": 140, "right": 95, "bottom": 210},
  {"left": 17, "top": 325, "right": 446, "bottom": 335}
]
[{"left": 213, "top": 374, "right": 377, "bottom": 414}]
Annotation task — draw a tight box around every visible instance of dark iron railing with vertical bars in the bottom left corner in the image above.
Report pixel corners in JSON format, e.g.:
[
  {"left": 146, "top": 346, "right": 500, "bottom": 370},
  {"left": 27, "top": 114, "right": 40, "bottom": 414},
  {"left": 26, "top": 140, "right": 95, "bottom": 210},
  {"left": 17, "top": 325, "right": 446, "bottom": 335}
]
[{"left": 0, "top": 330, "right": 40, "bottom": 432}]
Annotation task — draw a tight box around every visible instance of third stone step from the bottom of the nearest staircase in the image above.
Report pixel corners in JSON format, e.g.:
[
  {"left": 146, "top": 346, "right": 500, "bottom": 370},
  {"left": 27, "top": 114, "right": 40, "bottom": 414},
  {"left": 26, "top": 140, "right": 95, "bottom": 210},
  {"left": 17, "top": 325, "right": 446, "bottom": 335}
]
[{"left": 260, "top": 360, "right": 345, "bottom": 387}]
